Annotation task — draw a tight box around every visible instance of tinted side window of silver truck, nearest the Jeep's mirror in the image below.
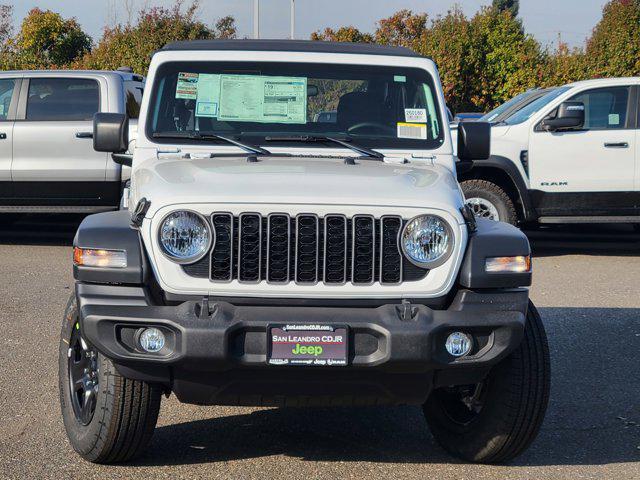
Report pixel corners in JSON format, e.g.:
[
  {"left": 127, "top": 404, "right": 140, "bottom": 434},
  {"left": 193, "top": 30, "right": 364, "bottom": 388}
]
[{"left": 26, "top": 78, "right": 100, "bottom": 121}]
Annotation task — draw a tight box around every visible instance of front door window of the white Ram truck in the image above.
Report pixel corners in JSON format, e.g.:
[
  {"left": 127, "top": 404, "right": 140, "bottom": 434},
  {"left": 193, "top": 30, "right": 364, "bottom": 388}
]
[{"left": 570, "top": 87, "right": 629, "bottom": 130}]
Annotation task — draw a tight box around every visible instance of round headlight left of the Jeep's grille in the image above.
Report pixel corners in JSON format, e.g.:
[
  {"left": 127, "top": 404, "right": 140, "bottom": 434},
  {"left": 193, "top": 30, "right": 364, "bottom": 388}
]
[{"left": 158, "top": 210, "right": 212, "bottom": 263}]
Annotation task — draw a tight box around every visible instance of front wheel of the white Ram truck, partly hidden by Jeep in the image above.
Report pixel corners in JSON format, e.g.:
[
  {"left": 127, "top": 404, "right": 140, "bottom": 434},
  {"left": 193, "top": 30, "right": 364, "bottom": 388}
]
[{"left": 460, "top": 180, "right": 518, "bottom": 225}]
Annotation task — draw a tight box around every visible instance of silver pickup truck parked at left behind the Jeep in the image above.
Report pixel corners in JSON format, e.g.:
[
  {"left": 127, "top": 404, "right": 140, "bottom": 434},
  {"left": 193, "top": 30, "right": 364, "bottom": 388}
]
[{"left": 0, "top": 67, "right": 144, "bottom": 214}]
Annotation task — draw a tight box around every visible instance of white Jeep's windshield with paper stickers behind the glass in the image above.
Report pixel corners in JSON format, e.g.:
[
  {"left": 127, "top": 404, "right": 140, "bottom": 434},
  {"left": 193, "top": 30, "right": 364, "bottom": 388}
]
[{"left": 146, "top": 62, "right": 444, "bottom": 149}]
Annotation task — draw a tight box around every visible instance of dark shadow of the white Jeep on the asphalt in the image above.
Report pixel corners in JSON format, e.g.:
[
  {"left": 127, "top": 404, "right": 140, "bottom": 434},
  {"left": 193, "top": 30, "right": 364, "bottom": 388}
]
[{"left": 136, "top": 308, "right": 640, "bottom": 466}]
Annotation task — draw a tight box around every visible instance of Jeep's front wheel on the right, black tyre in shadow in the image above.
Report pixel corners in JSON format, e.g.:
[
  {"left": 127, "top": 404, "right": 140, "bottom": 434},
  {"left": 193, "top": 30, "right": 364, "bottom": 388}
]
[{"left": 423, "top": 302, "right": 550, "bottom": 463}]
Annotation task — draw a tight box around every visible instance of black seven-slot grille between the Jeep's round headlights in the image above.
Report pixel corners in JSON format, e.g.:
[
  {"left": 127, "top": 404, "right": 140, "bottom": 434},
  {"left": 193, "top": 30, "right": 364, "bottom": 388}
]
[{"left": 182, "top": 212, "right": 428, "bottom": 285}]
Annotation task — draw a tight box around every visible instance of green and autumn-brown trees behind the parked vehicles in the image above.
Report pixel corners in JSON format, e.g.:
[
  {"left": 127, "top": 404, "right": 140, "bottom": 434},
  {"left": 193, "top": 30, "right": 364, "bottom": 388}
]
[{"left": 0, "top": 0, "right": 640, "bottom": 111}]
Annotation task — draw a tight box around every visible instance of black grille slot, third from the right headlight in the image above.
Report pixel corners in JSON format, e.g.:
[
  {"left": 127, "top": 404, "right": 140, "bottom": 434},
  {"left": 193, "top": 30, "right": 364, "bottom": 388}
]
[{"left": 324, "top": 215, "right": 347, "bottom": 283}]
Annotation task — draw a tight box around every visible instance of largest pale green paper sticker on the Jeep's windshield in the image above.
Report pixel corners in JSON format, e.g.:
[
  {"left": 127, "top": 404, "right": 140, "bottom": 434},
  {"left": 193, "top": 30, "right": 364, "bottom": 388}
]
[{"left": 218, "top": 75, "right": 307, "bottom": 123}]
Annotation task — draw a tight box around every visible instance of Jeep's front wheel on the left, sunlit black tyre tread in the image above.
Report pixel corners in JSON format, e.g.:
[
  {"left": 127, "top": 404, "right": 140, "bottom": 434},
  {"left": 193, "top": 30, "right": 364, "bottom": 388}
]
[{"left": 58, "top": 295, "right": 162, "bottom": 463}]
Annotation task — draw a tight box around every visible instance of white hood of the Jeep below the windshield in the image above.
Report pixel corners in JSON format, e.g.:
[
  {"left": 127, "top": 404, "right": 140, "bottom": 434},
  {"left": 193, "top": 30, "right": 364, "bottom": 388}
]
[{"left": 132, "top": 156, "right": 462, "bottom": 217}]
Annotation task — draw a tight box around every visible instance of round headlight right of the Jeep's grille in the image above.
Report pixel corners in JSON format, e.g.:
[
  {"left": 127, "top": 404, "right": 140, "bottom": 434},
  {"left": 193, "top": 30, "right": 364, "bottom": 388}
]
[{"left": 401, "top": 215, "right": 453, "bottom": 268}]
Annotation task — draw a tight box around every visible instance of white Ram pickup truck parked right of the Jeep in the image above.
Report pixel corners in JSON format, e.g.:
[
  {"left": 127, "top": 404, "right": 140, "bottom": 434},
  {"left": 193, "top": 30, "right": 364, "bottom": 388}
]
[{"left": 459, "top": 78, "right": 640, "bottom": 225}]
